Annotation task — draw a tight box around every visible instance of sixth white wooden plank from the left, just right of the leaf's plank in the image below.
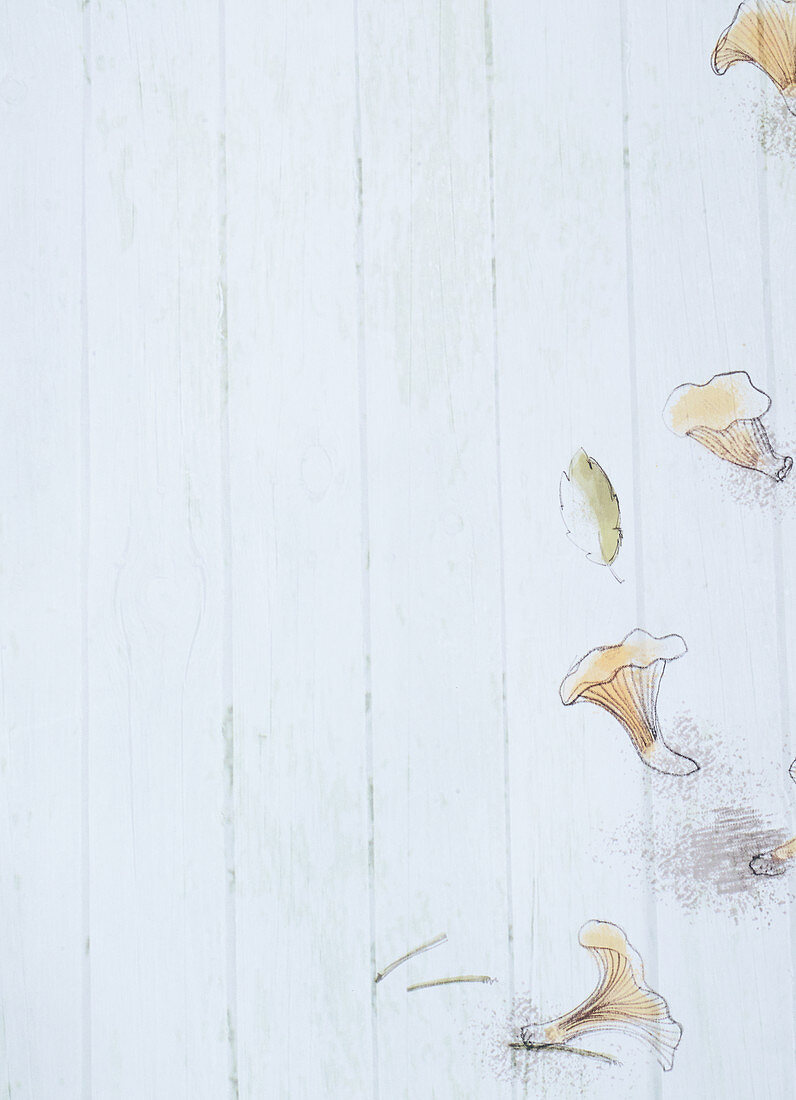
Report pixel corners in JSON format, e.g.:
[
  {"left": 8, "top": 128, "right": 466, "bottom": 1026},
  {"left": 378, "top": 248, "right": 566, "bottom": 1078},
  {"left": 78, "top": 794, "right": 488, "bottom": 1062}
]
[{"left": 628, "top": 2, "right": 794, "bottom": 1097}]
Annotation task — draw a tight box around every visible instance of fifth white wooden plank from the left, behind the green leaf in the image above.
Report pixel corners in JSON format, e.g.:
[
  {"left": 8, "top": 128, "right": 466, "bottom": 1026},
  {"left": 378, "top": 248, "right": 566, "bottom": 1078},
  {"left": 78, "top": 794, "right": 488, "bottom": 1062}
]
[{"left": 495, "top": 2, "right": 664, "bottom": 1097}]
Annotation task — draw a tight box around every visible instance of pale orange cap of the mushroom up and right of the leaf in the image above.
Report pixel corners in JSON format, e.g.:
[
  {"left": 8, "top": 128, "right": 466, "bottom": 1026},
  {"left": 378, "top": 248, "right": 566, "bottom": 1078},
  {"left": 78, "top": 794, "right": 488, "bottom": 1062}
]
[{"left": 663, "top": 371, "right": 771, "bottom": 436}]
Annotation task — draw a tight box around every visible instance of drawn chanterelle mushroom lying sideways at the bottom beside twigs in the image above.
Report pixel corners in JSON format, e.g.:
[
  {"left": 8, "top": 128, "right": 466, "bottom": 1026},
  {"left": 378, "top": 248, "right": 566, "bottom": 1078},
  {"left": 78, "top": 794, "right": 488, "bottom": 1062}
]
[{"left": 520, "top": 921, "right": 683, "bottom": 1069}]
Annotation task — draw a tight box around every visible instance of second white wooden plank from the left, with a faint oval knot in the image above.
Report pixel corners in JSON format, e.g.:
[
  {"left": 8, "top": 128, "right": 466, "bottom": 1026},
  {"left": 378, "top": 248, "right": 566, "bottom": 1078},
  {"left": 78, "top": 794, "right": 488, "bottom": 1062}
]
[{"left": 86, "top": 2, "right": 230, "bottom": 1097}]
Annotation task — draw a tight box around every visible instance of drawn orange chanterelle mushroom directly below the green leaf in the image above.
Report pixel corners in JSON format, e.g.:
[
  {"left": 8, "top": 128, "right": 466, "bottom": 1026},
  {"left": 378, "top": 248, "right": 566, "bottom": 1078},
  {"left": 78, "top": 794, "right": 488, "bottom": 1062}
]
[{"left": 561, "top": 630, "right": 699, "bottom": 776}]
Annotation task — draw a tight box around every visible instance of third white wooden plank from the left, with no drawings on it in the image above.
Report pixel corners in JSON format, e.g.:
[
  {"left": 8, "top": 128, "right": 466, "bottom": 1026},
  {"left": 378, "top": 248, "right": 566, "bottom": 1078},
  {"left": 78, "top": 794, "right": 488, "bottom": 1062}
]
[{"left": 225, "top": 0, "right": 375, "bottom": 1100}]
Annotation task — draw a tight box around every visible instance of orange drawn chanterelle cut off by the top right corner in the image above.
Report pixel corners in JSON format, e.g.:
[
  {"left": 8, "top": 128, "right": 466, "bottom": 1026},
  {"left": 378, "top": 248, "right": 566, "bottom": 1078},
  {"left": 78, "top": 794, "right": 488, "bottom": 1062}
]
[{"left": 711, "top": 0, "right": 796, "bottom": 114}]
